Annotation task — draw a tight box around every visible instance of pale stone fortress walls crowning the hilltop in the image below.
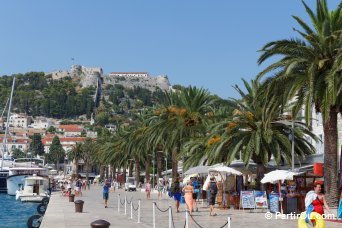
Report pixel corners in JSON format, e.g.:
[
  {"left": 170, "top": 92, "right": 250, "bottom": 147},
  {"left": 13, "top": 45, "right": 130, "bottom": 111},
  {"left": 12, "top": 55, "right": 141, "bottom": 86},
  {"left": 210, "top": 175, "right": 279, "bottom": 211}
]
[{"left": 46, "top": 65, "right": 171, "bottom": 91}]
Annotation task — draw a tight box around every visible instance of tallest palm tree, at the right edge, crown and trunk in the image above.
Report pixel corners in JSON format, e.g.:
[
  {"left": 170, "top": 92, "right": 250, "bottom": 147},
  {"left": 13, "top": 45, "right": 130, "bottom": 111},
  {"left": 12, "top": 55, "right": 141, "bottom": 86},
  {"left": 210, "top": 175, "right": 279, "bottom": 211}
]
[{"left": 258, "top": 0, "right": 342, "bottom": 205}]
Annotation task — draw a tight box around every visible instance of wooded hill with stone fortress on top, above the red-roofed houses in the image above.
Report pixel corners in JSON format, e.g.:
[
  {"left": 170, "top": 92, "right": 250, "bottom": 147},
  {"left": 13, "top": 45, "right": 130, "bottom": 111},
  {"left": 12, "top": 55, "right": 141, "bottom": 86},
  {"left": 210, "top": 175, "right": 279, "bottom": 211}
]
[{"left": 0, "top": 65, "right": 170, "bottom": 123}]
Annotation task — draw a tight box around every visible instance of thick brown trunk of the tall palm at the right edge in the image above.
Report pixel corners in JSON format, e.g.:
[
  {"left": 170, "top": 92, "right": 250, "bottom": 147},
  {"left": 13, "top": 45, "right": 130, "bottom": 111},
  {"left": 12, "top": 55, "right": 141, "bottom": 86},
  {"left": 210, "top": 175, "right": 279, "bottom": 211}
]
[{"left": 323, "top": 108, "right": 338, "bottom": 206}]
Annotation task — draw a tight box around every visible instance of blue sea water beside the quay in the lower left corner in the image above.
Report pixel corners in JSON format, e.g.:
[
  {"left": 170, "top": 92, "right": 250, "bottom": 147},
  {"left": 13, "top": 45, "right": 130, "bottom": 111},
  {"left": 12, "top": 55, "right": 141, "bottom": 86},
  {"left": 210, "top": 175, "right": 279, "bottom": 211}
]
[{"left": 0, "top": 194, "right": 39, "bottom": 228}]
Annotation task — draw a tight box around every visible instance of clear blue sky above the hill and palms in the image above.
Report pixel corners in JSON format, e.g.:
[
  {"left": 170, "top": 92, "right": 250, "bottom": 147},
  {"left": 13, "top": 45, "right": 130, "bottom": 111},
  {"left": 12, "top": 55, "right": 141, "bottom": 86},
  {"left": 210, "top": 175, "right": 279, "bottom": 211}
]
[{"left": 0, "top": 0, "right": 340, "bottom": 99}]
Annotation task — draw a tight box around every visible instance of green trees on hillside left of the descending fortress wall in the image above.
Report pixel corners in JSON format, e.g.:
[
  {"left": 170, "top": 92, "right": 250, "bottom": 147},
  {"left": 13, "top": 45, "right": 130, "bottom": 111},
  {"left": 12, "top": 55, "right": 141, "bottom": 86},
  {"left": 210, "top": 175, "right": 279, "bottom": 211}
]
[{"left": 0, "top": 72, "right": 95, "bottom": 118}]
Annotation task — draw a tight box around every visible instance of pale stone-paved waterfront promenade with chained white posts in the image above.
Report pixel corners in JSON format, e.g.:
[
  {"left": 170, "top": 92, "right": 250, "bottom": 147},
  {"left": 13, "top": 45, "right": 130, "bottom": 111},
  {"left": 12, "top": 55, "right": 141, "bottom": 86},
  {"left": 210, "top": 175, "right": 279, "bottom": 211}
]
[{"left": 41, "top": 186, "right": 341, "bottom": 228}]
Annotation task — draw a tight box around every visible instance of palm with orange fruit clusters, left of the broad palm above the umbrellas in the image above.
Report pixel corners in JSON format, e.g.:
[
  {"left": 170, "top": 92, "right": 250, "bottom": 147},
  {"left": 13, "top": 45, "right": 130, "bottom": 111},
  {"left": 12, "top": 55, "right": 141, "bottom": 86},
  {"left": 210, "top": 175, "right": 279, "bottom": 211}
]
[{"left": 148, "top": 87, "right": 215, "bottom": 179}]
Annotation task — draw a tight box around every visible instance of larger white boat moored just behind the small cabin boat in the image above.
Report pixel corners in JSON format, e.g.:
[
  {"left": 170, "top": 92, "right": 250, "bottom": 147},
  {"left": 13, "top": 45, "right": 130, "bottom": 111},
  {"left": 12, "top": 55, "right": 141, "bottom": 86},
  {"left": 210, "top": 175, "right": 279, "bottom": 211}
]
[{"left": 7, "top": 159, "right": 49, "bottom": 196}]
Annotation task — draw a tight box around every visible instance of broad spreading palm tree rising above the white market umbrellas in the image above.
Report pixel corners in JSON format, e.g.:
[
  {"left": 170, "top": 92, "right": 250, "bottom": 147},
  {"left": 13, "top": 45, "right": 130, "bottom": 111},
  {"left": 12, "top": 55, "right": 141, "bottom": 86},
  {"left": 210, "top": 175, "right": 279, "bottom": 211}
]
[{"left": 186, "top": 80, "right": 316, "bottom": 190}]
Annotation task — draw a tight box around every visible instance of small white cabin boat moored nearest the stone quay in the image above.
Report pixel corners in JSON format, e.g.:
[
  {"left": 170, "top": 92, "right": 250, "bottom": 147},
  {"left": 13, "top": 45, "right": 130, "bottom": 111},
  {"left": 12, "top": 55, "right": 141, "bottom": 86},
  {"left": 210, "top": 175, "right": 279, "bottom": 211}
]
[{"left": 16, "top": 175, "right": 49, "bottom": 202}]
